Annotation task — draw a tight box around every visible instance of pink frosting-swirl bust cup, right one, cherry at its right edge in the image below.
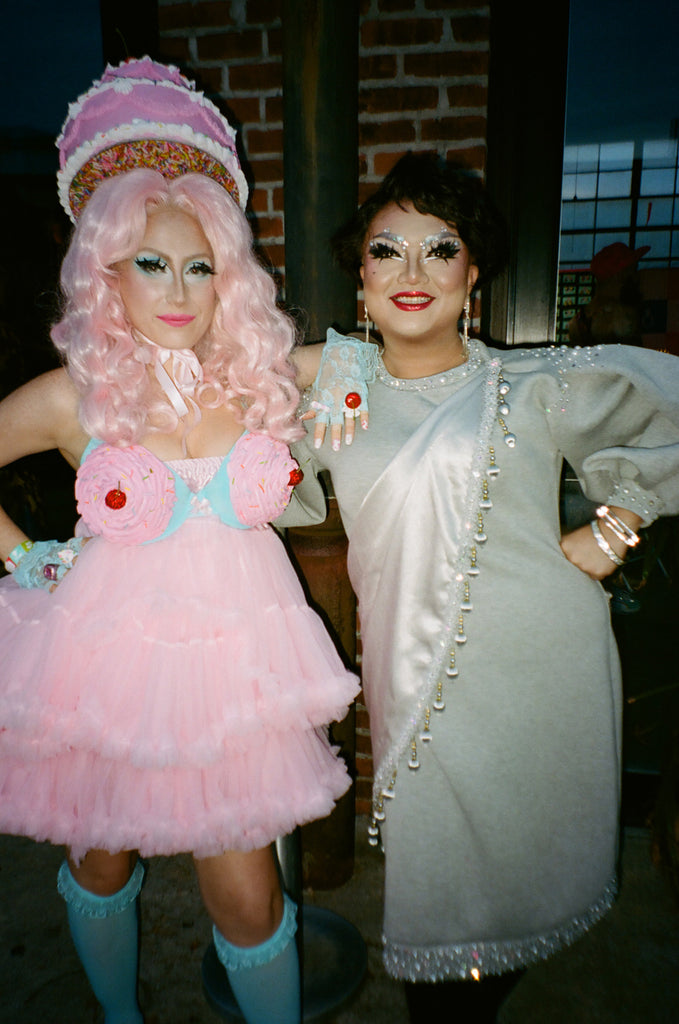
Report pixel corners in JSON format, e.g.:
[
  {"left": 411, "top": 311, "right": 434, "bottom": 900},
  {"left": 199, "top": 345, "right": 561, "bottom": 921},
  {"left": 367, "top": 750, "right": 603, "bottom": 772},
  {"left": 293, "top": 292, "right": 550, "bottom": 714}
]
[{"left": 228, "top": 433, "right": 303, "bottom": 526}]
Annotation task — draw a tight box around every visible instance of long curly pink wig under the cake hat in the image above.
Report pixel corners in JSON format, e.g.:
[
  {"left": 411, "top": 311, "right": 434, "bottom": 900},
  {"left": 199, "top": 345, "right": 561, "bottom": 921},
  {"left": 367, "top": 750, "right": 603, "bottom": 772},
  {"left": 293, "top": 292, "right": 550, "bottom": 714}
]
[{"left": 52, "top": 169, "right": 304, "bottom": 444}]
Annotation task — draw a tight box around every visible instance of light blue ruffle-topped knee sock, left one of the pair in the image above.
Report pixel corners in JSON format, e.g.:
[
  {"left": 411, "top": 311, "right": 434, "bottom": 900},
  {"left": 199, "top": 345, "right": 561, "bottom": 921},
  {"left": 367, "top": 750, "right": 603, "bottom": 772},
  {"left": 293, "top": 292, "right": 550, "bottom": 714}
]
[{"left": 56, "top": 861, "right": 143, "bottom": 1024}]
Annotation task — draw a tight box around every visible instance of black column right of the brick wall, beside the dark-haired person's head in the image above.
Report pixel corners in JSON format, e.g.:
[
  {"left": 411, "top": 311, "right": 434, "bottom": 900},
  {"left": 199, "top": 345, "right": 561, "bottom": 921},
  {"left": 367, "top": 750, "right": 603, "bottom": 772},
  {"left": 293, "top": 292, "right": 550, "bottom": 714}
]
[{"left": 481, "top": 0, "right": 568, "bottom": 345}]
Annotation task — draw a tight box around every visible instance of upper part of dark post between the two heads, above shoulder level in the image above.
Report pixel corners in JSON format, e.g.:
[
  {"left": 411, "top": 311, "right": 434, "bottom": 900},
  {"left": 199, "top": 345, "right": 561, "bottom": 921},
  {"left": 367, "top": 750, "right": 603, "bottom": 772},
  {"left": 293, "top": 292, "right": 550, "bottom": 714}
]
[{"left": 283, "top": 0, "right": 358, "bottom": 341}]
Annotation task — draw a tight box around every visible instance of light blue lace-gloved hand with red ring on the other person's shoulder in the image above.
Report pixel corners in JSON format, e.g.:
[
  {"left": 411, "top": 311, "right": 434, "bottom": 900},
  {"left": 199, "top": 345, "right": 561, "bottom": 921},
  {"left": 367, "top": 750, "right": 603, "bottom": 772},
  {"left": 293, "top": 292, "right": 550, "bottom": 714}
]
[{"left": 308, "top": 329, "right": 377, "bottom": 451}]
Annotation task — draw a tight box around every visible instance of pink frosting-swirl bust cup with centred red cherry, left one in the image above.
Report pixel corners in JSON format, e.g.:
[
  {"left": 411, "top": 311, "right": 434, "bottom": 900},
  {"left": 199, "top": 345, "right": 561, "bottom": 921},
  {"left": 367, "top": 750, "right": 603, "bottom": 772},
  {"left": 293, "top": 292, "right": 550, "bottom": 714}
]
[{"left": 76, "top": 444, "right": 176, "bottom": 544}]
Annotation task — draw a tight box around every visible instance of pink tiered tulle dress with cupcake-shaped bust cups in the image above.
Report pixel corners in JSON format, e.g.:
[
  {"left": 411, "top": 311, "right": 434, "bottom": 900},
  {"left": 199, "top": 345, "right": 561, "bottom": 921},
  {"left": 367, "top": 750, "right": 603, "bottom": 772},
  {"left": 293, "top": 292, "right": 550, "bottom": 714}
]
[{"left": 0, "top": 433, "right": 358, "bottom": 857}]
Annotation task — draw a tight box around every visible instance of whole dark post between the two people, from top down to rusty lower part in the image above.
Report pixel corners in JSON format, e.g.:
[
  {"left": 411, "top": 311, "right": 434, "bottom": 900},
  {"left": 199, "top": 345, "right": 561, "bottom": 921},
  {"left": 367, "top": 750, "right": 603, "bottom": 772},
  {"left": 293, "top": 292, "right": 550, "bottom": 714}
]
[{"left": 283, "top": 0, "right": 358, "bottom": 889}]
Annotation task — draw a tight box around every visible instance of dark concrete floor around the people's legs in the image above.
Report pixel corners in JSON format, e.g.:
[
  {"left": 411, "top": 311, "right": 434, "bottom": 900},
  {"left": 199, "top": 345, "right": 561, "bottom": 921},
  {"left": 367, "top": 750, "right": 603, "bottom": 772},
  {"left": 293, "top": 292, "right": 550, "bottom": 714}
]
[{"left": 0, "top": 822, "right": 679, "bottom": 1024}]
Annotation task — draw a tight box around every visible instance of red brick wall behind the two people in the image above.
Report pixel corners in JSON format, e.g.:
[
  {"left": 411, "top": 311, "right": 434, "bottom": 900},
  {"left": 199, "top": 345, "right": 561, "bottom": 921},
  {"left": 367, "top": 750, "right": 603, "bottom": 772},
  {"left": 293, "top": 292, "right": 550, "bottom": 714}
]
[{"left": 159, "top": 0, "right": 490, "bottom": 814}]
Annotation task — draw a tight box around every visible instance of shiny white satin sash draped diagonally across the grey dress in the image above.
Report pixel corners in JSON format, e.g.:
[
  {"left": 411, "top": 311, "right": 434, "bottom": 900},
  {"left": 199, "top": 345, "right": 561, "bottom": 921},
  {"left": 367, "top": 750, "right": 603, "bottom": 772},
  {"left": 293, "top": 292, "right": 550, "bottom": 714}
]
[{"left": 348, "top": 359, "right": 501, "bottom": 799}]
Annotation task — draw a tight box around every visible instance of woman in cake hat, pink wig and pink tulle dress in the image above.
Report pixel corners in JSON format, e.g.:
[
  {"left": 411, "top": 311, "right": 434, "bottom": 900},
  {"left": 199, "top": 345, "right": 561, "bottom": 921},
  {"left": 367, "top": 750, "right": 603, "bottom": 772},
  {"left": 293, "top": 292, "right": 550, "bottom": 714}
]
[{"left": 0, "top": 58, "right": 357, "bottom": 1024}]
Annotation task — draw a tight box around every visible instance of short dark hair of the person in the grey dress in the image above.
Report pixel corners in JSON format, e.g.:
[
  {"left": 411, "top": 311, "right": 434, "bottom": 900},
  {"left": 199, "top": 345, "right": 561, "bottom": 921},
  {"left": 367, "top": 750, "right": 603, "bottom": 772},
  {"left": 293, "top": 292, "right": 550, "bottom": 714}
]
[{"left": 332, "top": 153, "right": 507, "bottom": 284}]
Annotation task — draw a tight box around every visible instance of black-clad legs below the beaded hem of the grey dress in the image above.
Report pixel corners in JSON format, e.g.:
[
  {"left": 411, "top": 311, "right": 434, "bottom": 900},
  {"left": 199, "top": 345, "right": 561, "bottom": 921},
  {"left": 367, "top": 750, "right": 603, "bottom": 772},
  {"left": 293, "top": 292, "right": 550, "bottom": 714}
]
[{"left": 406, "top": 971, "right": 524, "bottom": 1024}]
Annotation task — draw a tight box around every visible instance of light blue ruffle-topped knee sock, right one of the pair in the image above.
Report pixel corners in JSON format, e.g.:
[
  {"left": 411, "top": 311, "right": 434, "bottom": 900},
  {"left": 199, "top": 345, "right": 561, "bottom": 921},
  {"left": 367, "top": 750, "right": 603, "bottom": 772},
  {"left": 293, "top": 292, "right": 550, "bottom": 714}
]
[{"left": 212, "top": 894, "right": 301, "bottom": 1024}]
